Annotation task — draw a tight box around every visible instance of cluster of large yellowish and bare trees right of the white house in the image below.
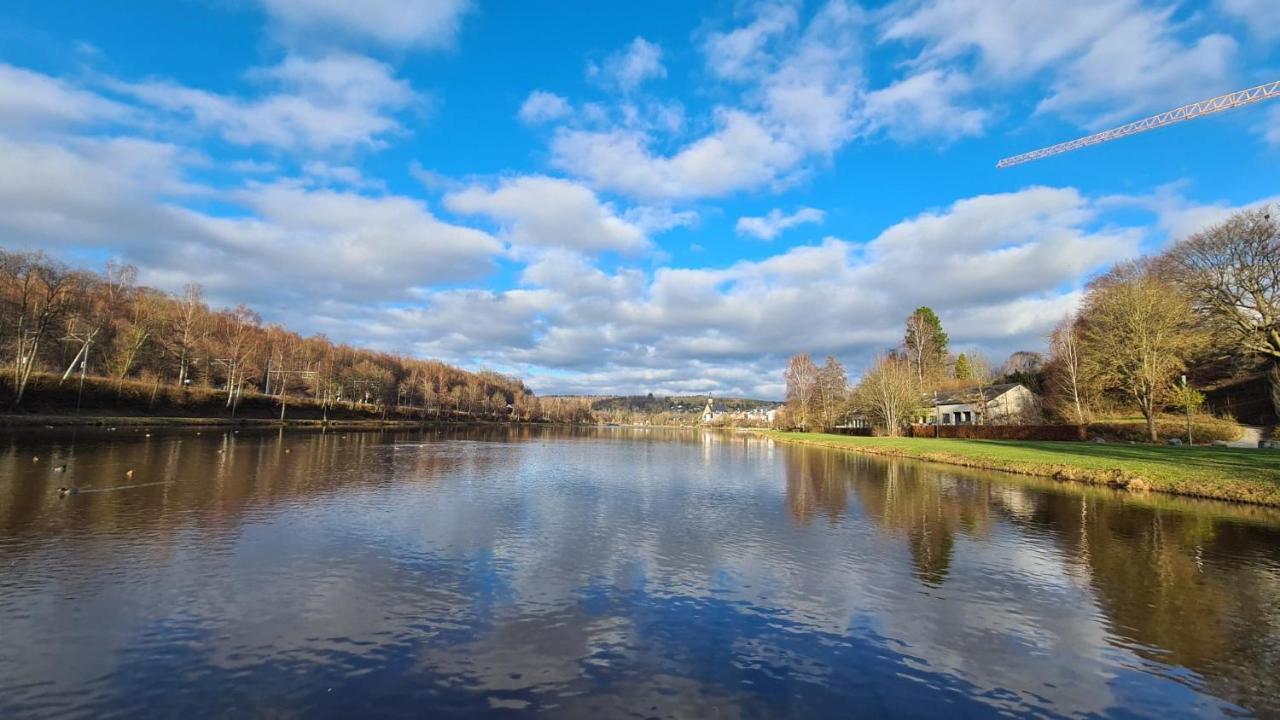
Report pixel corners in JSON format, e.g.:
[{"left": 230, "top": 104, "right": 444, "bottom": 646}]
[{"left": 1047, "top": 206, "right": 1280, "bottom": 439}]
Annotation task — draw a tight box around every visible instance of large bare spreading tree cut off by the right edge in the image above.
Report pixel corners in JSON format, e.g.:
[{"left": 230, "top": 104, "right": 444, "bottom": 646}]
[{"left": 1161, "top": 206, "right": 1280, "bottom": 415}]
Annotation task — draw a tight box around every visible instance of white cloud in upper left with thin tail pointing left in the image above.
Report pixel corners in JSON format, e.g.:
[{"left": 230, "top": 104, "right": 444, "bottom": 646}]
[{"left": 113, "top": 54, "right": 420, "bottom": 150}]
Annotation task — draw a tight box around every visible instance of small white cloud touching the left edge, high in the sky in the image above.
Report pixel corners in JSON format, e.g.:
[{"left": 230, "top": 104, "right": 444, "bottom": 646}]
[{"left": 0, "top": 63, "right": 131, "bottom": 131}]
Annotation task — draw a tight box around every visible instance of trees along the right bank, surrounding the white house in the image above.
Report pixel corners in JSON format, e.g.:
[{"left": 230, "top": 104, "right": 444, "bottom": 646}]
[{"left": 785, "top": 208, "right": 1280, "bottom": 441}]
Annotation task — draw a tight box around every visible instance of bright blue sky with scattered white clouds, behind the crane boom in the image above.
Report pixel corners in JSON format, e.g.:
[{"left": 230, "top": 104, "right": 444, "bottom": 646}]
[{"left": 0, "top": 0, "right": 1280, "bottom": 397}]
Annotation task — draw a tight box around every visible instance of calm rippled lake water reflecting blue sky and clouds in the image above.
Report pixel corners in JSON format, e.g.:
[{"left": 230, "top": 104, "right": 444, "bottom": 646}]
[{"left": 0, "top": 429, "right": 1280, "bottom": 717}]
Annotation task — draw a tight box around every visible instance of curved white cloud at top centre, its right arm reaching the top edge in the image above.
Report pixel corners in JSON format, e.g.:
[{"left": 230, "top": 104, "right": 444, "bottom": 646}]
[{"left": 552, "top": 0, "right": 864, "bottom": 199}]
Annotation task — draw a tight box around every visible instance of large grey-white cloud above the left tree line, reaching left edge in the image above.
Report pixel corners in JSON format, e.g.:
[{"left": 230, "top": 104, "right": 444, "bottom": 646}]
[{"left": 0, "top": 131, "right": 503, "bottom": 304}]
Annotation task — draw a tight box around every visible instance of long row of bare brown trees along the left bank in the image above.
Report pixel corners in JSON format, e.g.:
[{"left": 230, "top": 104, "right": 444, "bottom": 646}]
[{"left": 0, "top": 250, "right": 581, "bottom": 421}]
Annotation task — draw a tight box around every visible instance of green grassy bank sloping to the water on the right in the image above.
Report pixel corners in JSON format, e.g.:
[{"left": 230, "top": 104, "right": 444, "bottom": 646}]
[{"left": 762, "top": 430, "right": 1280, "bottom": 506}]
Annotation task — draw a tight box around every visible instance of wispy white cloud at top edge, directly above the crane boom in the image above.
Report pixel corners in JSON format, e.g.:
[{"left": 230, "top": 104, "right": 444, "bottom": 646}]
[{"left": 883, "top": 0, "right": 1235, "bottom": 124}]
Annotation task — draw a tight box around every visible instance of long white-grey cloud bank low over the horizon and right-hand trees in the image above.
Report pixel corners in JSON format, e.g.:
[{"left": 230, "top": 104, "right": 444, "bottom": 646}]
[{"left": 307, "top": 187, "right": 1146, "bottom": 397}]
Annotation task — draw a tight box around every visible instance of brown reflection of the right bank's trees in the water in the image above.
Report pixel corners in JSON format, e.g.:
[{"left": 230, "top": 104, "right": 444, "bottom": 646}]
[{"left": 785, "top": 447, "right": 1280, "bottom": 698}]
